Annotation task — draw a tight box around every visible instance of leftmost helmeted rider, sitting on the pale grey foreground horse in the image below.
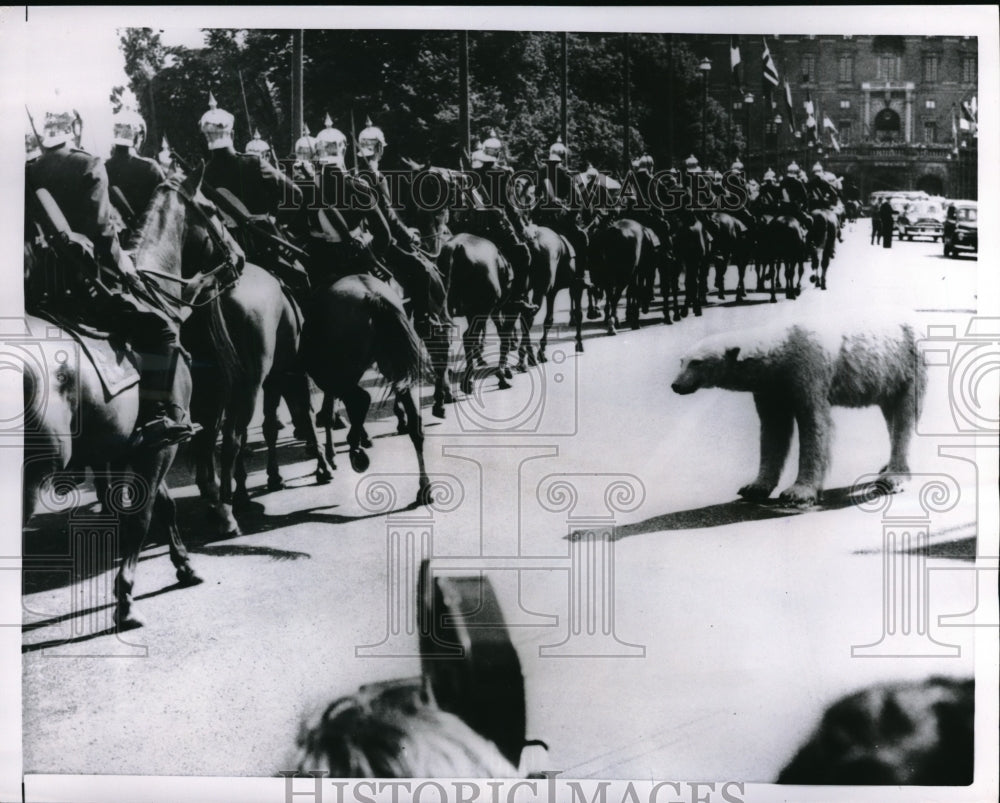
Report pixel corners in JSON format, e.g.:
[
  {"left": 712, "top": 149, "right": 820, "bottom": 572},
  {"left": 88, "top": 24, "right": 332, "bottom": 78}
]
[{"left": 26, "top": 99, "right": 200, "bottom": 449}]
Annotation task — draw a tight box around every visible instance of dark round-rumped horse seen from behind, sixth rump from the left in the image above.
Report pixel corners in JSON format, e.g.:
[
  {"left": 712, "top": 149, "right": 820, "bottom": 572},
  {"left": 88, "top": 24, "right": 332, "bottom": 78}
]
[{"left": 588, "top": 218, "right": 656, "bottom": 335}]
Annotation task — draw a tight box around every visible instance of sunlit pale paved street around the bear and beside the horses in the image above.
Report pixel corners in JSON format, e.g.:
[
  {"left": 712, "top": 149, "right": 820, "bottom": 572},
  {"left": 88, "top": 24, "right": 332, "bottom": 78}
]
[{"left": 23, "top": 226, "right": 984, "bottom": 781}]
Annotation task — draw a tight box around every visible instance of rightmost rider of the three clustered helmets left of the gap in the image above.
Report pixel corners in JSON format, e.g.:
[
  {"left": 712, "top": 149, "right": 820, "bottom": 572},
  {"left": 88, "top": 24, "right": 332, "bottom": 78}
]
[{"left": 358, "top": 119, "right": 445, "bottom": 337}]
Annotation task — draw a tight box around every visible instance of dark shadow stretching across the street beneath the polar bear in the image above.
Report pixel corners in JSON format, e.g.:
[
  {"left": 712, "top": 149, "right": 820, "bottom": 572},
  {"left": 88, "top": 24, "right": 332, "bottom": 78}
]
[{"left": 596, "top": 487, "right": 855, "bottom": 541}]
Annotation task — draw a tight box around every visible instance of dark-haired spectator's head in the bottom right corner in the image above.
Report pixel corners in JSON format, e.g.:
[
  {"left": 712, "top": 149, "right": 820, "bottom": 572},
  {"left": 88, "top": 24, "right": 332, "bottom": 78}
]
[{"left": 778, "top": 677, "right": 975, "bottom": 786}]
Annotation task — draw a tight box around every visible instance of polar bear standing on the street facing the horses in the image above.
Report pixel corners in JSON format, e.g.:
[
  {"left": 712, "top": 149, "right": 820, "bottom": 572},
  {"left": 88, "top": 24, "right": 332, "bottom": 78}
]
[{"left": 671, "top": 311, "right": 927, "bottom": 505}]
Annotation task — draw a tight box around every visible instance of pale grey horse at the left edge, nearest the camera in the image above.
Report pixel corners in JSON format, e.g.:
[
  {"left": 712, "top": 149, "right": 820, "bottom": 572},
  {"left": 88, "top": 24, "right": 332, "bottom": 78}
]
[{"left": 23, "top": 173, "right": 229, "bottom": 630}]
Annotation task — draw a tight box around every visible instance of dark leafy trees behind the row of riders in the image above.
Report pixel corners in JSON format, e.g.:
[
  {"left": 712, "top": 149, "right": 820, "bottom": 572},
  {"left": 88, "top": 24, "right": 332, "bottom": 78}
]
[{"left": 118, "top": 28, "right": 729, "bottom": 172}]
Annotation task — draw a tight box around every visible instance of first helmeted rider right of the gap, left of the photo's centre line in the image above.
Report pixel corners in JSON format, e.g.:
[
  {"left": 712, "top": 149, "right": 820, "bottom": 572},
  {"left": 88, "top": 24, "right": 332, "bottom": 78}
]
[{"left": 470, "top": 130, "right": 538, "bottom": 314}]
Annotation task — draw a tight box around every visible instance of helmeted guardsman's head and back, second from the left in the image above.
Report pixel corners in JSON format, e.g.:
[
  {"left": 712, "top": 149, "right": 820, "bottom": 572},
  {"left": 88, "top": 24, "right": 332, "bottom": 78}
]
[{"left": 104, "top": 106, "right": 166, "bottom": 242}]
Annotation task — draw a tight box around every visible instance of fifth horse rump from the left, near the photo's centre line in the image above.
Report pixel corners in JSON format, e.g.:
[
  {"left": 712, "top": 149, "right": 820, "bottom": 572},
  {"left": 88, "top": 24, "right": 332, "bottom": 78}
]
[{"left": 517, "top": 224, "right": 584, "bottom": 371}]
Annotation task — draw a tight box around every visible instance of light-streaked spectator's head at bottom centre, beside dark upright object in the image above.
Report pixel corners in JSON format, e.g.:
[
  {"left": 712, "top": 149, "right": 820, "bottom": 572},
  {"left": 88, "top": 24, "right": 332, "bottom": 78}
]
[{"left": 297, "top": 681, "right": 519, "bottom": 778}]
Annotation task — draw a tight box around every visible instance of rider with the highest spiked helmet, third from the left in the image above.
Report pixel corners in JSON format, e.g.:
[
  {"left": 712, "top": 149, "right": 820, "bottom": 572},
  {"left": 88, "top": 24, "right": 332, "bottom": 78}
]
[{"left": 199, "top": 93, "right": 308, "bottom": 289}]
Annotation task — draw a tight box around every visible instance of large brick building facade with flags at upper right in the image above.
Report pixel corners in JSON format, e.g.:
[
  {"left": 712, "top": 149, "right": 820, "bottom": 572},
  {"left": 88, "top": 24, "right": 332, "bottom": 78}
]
[{"left": 695, "top": 35, "right": 979, "bottom": 200}]
